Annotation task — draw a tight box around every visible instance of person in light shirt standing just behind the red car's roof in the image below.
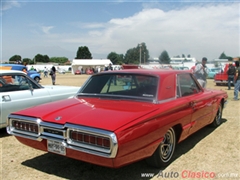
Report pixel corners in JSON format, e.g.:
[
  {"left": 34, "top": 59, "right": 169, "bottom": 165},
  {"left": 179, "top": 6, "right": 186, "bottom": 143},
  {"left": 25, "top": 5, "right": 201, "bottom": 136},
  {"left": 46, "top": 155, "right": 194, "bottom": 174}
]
[{"left": 194, "top": 57, "right": 208, "bottom": 88}]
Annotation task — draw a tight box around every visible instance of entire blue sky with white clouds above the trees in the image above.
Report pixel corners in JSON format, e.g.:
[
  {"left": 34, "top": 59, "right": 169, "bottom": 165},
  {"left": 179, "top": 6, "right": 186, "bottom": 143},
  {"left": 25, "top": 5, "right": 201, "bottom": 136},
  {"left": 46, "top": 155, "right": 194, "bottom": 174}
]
[{"left": 0, "top": 0, "right": 240, "bottom": 61}]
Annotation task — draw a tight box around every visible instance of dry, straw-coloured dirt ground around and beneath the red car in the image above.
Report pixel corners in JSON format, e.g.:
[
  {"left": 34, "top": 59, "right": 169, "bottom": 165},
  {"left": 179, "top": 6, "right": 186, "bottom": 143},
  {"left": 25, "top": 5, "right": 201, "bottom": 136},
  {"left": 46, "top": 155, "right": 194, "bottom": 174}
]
[{"left": 0, "top": 74, "right": 240, "bottom": 180}]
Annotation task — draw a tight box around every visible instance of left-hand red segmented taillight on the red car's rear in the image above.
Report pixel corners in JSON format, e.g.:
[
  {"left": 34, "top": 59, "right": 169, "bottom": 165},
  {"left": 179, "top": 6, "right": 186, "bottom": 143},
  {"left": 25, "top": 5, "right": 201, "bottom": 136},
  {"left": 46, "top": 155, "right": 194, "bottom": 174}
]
[{"left": 12, "top": 120, "right": 38, "bottom": 134}]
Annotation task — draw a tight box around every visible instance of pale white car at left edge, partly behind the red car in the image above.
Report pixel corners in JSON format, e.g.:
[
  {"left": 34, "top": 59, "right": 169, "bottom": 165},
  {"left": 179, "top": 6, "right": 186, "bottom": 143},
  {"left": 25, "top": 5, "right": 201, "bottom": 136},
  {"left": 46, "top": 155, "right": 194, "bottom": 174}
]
[{"left": 0, "top": 70, "right": 80, "bottom": 128}]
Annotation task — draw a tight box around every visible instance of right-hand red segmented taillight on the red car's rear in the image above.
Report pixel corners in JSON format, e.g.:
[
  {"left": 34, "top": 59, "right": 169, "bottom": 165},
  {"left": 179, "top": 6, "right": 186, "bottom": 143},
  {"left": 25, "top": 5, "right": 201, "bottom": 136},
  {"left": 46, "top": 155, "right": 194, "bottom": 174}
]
[{"left": 70, "top": 131, "right": 111, "bottom": 148}]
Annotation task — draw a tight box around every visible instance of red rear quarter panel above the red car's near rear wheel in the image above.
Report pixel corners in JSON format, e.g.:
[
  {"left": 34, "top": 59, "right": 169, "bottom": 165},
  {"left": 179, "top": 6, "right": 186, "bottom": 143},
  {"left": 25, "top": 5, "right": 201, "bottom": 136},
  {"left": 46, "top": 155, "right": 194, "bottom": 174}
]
[{"left": 115, "top": 98, "right": 192, "bottom": 164}]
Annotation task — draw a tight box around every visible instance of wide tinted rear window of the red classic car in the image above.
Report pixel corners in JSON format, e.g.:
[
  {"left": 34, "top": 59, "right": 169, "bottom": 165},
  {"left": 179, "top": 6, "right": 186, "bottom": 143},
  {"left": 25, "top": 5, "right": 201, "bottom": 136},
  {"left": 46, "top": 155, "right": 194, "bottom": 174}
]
[{"left": 79, "top": 73, "right": 158, "bottom": 100}]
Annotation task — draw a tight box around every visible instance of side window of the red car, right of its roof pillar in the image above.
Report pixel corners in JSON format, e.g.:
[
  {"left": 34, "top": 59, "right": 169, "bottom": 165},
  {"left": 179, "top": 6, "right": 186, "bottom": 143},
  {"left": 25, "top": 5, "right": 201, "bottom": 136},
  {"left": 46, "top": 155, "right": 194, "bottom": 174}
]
[{"left": 177, "top": 74, "right": 200, "bottom": 97}]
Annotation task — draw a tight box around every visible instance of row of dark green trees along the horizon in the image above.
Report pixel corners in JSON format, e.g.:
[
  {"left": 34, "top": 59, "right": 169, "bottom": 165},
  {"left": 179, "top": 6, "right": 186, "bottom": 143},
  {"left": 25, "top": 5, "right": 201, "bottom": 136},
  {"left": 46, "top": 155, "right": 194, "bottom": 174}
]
[{"left": 5, "top": 42, "right": 238, "bottom": 65}]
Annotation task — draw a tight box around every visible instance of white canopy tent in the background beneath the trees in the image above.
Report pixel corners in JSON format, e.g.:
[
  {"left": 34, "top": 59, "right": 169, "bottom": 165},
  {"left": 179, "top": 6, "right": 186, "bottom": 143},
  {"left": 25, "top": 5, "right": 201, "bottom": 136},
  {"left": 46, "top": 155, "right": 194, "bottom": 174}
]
[{"left": 72, "top": 59, "right": 112, "bottom": 74}]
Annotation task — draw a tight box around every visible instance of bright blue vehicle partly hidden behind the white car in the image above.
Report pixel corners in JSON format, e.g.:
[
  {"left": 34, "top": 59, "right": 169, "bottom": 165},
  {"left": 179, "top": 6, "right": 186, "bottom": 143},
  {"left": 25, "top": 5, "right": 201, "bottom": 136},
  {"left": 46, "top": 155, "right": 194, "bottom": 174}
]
[{"left": 1, "top": 64, "right": 41, "bottom": 83}]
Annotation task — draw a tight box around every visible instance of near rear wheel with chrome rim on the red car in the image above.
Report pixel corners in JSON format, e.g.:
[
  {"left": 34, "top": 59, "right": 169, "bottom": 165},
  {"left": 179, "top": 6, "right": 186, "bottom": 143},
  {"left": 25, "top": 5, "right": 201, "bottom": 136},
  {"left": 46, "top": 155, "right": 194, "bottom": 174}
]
[{"left": 146, "top": 128, "right": 176, "bottom": 168}]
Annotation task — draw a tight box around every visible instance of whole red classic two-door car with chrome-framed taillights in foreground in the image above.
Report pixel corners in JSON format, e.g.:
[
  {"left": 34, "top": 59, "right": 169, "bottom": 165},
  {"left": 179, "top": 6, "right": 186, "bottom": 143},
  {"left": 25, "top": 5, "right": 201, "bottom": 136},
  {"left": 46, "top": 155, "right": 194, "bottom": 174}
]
[{"left": 7, "top": 69, "right": 228, "bottom": 168}]
